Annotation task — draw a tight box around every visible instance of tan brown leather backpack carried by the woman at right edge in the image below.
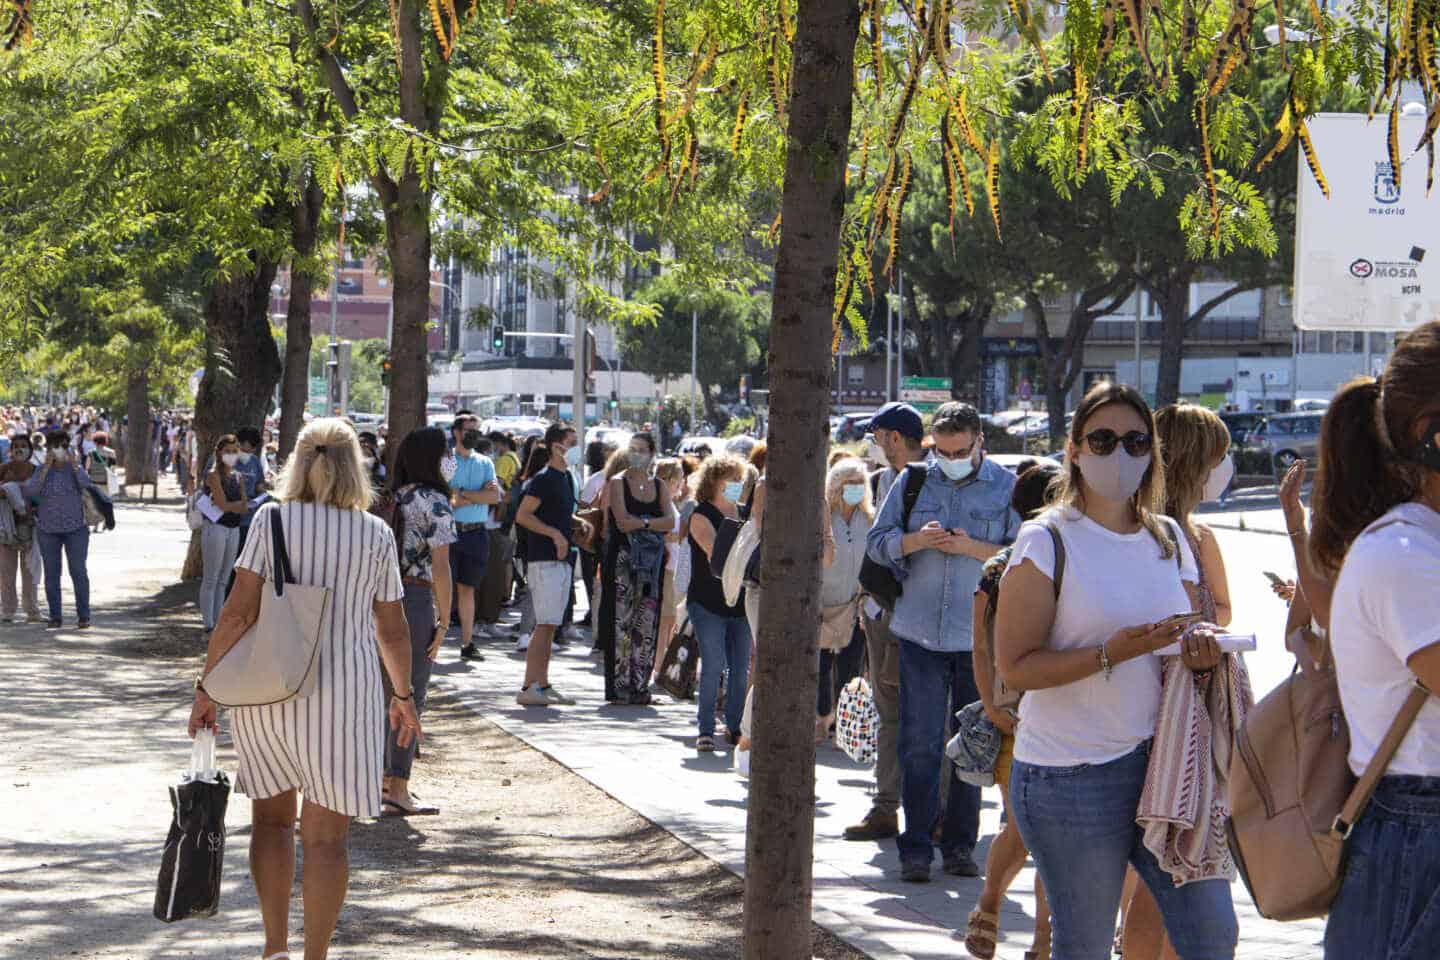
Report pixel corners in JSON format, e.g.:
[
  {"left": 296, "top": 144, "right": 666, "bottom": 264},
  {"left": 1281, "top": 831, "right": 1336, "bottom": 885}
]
[{"left": 1225, "top": 630, "right": 1430, "bottom": 920}]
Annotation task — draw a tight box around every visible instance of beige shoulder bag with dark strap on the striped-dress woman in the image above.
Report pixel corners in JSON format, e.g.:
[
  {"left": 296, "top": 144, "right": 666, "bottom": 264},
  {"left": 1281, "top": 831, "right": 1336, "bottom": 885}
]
[{"left": 204, "top": 507, "right": 331, "bottom": 707}]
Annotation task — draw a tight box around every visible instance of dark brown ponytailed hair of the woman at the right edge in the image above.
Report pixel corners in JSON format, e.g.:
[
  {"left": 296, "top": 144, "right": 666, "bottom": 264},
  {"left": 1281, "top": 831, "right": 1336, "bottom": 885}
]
[{"left": 1310, "top": 322, "right": 1440, "bottom": 580}]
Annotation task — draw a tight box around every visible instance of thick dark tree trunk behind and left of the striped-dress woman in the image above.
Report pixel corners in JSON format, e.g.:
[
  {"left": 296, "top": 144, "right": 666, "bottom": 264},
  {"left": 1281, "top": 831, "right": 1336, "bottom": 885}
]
[{"left": 180, "top": 255, "right": 281, "bottom": 580}]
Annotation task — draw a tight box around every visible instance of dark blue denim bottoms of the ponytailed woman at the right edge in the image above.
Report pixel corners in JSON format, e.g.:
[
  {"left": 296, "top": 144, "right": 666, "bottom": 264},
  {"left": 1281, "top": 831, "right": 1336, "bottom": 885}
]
[{"left": 1325, "top": 776, "right": 1440, "bottom": 960}]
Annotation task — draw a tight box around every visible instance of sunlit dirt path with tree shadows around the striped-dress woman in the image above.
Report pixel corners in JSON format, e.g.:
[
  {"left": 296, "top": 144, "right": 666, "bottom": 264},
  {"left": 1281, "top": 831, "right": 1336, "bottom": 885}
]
[{"left": 0, "top": 492, "right": 863, "bottom": 960}]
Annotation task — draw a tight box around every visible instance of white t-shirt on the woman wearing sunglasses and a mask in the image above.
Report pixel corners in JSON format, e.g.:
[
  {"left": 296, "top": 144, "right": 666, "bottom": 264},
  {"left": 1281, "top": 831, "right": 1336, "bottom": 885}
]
[{"left": 1002, "top": 507, "right": 1200, "bottom": 767}]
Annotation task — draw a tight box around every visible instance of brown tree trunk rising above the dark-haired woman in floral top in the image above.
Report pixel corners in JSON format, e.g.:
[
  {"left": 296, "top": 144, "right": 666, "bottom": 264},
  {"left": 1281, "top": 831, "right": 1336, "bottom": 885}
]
[{"left": 382, "top": 4, "right": 444, "bottom": 443}]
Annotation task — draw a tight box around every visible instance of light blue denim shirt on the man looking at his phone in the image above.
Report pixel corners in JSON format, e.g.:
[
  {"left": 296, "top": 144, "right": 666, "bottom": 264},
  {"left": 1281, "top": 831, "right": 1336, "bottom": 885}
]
[{"left": 867, "top": 458, "right": 1020, "bottom": 653}]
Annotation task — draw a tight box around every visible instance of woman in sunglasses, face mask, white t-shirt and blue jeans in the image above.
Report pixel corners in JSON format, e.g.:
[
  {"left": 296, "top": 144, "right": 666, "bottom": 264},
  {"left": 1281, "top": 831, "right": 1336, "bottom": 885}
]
[{"left": 995, "top": 383, "right": 1238, "bottom": 960}]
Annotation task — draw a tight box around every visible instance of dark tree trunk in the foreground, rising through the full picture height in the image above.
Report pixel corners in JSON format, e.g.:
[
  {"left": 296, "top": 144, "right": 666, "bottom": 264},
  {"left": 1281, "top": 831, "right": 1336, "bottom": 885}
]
[{"left": 744, "top": 0, "right": 860, "bottom": 960}]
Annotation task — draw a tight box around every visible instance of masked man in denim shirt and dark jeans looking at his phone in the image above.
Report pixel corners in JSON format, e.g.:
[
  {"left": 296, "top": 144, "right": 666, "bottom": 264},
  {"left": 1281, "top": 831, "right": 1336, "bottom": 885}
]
[{"left": 867, "top": 403, "right": 1020, "bottom": 882}]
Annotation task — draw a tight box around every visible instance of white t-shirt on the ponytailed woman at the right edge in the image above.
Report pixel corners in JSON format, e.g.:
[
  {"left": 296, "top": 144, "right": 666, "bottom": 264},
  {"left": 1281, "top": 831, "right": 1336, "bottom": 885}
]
[{"left": 1331, "top": 504, "right": 1440, "bottom": 777}]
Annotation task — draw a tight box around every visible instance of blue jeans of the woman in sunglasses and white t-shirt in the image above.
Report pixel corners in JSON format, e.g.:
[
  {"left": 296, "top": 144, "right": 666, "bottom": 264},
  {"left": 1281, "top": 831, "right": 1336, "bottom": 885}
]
[{"left": 1009, "top": 741, "right": 1238, "bottom": 960}]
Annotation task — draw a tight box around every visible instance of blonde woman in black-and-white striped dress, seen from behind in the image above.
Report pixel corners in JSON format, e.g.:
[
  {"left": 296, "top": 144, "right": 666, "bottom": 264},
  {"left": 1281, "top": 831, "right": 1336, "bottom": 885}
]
[{"left": 190, "top": 419, "right": 420, "bottom": 960}]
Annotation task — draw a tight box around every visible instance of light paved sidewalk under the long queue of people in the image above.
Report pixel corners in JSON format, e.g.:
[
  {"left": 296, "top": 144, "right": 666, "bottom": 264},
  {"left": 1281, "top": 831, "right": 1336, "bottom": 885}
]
[{"left": 436, "top": 618, "right": 1323, "bottom": 960}]
